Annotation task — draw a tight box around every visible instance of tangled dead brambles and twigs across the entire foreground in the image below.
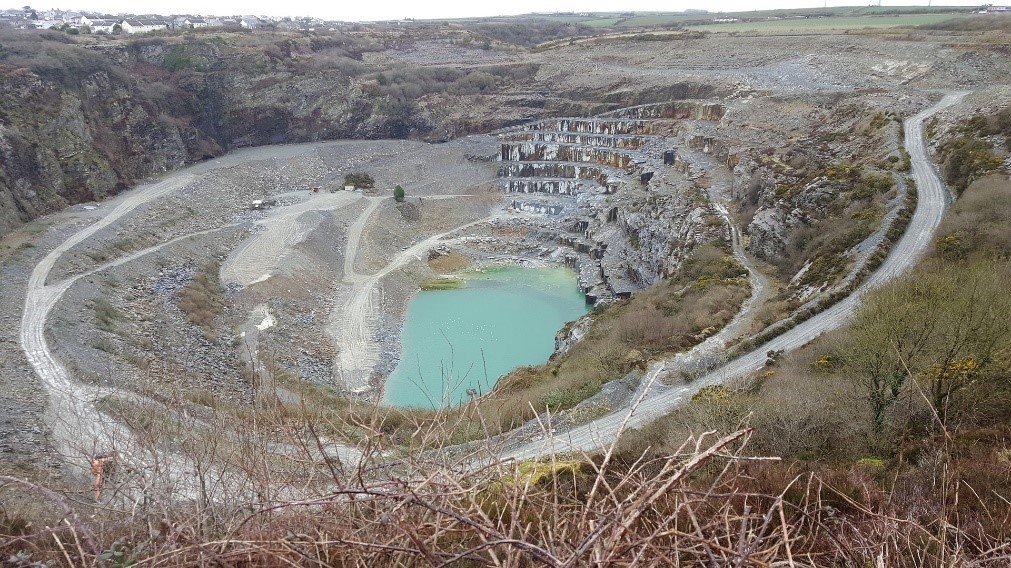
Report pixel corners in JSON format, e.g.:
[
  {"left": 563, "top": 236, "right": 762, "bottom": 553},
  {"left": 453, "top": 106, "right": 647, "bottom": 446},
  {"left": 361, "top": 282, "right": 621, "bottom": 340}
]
[{"left": 0, "top": 373, "right": 1011, "bottom": 567}]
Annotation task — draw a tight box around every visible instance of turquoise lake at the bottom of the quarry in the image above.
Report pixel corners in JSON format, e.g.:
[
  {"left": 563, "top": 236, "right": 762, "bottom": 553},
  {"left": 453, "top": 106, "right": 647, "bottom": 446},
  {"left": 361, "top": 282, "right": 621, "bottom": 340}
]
[{"left": 383, "top": 267, "right": 588, "bottom": 408}]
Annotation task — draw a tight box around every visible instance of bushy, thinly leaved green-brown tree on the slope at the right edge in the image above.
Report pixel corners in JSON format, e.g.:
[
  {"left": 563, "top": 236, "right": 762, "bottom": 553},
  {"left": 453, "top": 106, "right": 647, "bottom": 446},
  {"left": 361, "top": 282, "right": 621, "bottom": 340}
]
[{"left": 841, "top": 263, "right": 1011, "bottom": 433}]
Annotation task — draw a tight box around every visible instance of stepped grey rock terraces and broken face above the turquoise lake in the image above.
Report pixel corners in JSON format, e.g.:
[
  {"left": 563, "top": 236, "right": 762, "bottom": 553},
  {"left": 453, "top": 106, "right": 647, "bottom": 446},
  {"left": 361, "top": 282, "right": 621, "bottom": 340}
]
[{"left": 498, "top": 101, "right": 728, "bottom": 303}]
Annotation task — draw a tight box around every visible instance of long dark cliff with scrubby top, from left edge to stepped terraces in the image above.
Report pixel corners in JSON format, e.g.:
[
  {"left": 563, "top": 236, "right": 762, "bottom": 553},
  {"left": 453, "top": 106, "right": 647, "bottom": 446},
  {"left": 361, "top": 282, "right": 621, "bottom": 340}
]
[{"left": 0, "top": 31, "right": 536, "bottom": 233}]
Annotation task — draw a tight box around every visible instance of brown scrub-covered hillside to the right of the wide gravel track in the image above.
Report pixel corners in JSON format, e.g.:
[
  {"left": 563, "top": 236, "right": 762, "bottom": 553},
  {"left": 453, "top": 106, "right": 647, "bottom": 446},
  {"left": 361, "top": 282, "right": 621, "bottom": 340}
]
[{"left": 618, "top": 179, "right": 1011, "bottom": 567}]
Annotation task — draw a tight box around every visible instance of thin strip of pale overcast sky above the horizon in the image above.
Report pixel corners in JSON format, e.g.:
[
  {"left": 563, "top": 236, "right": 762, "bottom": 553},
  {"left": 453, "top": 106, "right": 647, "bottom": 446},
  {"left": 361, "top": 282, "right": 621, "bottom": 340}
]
[{"left": 29, "top": 0, "right": 986, "bottom": 21}]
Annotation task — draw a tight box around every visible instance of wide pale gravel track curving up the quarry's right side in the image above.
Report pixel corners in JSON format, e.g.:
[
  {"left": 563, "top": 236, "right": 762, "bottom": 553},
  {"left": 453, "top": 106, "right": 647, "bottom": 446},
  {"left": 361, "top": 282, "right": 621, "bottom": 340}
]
[{"left": 501, "top": 92, "right": 968, "bottom": 459}]
